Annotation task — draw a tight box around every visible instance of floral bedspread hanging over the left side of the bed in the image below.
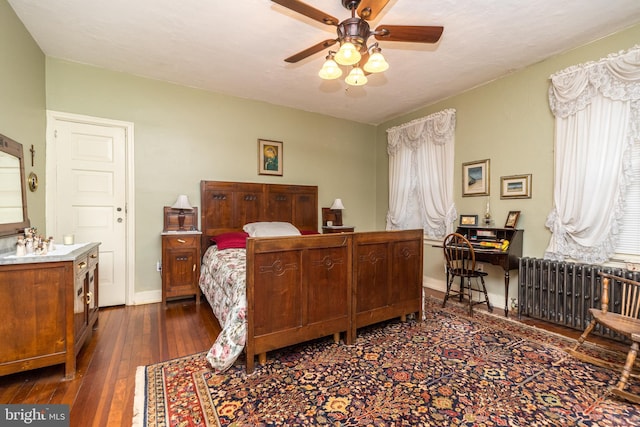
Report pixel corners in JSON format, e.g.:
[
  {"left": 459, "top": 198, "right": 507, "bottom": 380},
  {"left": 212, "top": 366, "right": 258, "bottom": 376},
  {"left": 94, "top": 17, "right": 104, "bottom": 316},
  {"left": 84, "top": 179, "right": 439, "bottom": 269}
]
[{"left": 199, "top": 245, "right": 247, "bottom": 371}]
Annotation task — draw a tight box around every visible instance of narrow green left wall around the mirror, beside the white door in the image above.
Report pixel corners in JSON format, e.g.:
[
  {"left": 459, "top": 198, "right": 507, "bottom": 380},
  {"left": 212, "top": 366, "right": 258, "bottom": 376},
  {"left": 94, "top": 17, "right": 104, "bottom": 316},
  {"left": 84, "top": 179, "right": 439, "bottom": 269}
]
[{"left": 0, "top": 0, "right": 45, "bottom": 254}]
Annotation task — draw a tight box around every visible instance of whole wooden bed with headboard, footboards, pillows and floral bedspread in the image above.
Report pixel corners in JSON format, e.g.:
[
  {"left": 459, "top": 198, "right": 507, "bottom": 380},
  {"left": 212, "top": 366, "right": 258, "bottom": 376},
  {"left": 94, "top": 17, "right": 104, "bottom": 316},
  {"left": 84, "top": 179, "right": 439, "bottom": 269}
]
[{"left": 200, "top": 181, "right": 423, "bottom": 373}]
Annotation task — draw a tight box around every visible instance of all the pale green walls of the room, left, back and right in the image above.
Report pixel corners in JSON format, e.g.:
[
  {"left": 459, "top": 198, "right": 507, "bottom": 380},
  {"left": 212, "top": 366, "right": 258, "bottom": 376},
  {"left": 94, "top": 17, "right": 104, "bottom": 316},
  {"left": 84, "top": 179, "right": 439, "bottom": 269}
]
[{"left": 5, "top": 0, "right": 640, "bottom": 305}]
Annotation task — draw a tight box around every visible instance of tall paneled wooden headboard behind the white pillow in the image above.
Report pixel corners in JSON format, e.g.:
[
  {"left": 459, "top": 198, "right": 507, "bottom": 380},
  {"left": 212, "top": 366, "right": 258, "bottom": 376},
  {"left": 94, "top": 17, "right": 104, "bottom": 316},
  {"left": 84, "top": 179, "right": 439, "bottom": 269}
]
[{"left": 200, "top": 181, "right": 318, "bottom": 254}]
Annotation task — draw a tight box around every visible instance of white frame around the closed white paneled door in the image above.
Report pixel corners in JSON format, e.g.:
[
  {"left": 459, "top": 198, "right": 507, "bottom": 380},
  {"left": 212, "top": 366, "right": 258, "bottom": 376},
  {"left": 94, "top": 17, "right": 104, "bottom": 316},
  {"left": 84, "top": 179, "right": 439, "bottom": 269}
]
[{"left": 45, "top": 110, "right": 136, "bottom": 305}]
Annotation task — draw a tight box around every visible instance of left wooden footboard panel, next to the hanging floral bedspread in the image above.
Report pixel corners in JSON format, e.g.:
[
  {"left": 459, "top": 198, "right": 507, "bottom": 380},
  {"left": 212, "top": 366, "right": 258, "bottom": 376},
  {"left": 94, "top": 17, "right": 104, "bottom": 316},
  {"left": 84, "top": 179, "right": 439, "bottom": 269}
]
[{"left": 246, "top": 233, "right": 354, "bottom": 373}]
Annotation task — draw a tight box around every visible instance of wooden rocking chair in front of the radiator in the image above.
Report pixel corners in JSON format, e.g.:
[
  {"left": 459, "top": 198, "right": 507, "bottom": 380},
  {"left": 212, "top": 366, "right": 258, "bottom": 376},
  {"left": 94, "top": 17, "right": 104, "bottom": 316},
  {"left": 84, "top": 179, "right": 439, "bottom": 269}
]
[{"left": 567, "top": 273, "right": 640, "bottom": 403}]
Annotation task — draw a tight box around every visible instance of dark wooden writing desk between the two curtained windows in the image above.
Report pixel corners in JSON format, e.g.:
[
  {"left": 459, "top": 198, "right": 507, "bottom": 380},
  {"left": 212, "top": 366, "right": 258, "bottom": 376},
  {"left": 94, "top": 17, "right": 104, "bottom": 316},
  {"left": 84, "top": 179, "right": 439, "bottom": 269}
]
[{"left": 456, "top": 226, "right": 524, "bottom": 316}]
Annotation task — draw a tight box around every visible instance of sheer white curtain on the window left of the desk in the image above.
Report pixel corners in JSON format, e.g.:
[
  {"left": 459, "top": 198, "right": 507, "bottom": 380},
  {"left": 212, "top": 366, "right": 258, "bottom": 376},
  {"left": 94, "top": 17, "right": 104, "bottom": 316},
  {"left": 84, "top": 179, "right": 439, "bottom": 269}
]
[{"left": 387, "top": 109, "right": 457, "bottom": 238}]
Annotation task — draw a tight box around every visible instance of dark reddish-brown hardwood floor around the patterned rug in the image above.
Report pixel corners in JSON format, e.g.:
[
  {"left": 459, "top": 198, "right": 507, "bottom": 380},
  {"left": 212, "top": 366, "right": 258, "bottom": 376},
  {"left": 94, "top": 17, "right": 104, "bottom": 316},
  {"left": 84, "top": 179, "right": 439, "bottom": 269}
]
[{"left": 0, "top": 291, "right": 627, "bottom": 427}]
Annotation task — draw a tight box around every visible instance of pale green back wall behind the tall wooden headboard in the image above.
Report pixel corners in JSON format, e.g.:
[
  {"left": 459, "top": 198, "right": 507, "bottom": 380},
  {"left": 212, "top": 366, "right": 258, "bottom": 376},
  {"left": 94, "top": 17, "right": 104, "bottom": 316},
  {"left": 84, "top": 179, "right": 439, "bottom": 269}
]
[{"left": 46, "top": 58, "right": 376, "bottom": 292}]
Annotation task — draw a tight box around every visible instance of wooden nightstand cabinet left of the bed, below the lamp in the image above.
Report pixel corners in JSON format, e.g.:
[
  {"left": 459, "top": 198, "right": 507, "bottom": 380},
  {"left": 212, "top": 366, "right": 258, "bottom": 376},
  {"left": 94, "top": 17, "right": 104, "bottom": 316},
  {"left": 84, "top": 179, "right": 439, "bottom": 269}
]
[{"left": 162, "top": 231, "right": 202, "bottom": 304}]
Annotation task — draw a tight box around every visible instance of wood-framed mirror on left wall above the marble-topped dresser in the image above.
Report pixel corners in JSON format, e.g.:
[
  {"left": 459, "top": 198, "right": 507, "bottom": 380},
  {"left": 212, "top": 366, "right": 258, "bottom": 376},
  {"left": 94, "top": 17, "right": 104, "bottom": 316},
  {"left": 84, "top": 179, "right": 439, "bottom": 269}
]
[{"left": 0, "top": 135, "right": 29, "bottom": 237}]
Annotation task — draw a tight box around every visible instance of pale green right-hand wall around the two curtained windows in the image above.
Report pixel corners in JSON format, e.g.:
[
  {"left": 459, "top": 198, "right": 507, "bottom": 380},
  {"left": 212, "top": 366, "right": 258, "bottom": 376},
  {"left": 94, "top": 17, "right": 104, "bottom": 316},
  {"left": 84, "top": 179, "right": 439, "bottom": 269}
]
[{"left": 376, "top": 25, "right": 640, "bottom": 306}]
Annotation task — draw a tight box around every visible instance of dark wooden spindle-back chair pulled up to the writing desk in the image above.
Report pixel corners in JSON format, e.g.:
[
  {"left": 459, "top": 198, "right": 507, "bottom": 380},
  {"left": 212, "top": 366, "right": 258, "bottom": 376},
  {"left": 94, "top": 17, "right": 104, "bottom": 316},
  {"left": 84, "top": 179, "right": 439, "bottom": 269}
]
[{"left": 442, "top": 233, "right": 493, "bottom": 315}]
